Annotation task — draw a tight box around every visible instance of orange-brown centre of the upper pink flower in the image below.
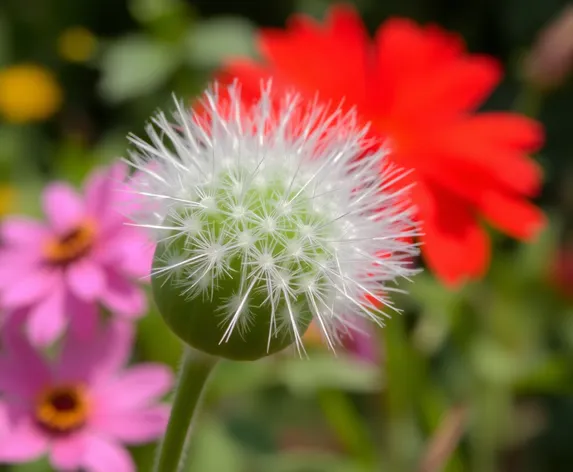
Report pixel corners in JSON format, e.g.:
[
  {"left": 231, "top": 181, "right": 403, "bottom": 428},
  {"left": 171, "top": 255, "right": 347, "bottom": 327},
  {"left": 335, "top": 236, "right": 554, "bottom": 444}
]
[{"left": 44, "top": 221, "right": 95, "bottom": 265}]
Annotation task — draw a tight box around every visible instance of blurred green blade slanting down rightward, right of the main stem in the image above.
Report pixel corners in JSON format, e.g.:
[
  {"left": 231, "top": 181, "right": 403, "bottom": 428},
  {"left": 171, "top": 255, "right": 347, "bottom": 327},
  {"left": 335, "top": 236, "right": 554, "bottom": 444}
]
[{"left": 318, "top": 390, "right": 376, "bottom": 470}]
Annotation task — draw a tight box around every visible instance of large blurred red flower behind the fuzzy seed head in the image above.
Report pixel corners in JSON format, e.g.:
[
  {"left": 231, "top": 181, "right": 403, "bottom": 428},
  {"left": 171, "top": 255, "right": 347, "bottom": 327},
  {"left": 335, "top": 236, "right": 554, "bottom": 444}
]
[{"left": 219, "top": 6, "right": 544, "bottom": 285}]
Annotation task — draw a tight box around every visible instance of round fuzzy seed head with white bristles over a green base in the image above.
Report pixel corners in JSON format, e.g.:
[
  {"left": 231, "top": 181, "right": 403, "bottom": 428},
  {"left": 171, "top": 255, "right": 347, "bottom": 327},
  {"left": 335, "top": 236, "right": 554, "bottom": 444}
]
[{"left": 126, "top": 85, "right": 417, "bottom": 359}]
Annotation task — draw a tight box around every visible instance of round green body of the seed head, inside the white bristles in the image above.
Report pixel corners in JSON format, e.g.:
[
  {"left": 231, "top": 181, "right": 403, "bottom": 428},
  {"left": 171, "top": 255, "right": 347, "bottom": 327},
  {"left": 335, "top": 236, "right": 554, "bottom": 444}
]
[{"left": 152, "top": 171, "right": 328, "bottom": 360}]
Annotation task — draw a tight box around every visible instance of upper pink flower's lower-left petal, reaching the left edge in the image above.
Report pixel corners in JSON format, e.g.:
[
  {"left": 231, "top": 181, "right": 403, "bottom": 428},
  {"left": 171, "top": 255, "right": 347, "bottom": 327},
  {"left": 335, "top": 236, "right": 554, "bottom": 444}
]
[{"left": 1, "top": 267, "right": 59, "bottom": 309}]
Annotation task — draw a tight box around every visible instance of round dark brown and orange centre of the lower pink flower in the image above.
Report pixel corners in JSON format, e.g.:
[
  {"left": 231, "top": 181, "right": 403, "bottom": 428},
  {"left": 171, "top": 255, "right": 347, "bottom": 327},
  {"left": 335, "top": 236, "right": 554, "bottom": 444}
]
[{"left": 35, "top": 385, "right": 88, "bottom": 434}]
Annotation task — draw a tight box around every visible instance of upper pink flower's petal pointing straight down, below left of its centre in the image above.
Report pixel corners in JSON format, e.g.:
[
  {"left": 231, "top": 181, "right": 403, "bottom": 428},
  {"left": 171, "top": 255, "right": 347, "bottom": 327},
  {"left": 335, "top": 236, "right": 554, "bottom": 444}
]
[{"left": 26, "top": 289, "right": 67, "bottom": 346}]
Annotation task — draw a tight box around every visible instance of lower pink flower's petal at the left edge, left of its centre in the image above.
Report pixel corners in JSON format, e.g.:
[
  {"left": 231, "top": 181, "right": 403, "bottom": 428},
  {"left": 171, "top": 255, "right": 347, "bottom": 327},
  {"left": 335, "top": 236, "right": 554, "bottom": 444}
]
[{"left": 0, "top": 404, "right": 48, "bottom": 463}]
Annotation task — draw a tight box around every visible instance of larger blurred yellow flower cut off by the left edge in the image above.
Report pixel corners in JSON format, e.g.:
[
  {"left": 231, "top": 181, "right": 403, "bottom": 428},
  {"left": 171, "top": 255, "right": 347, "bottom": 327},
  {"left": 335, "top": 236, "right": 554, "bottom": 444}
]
[{"left": 0, "top": 64, "right": 62, "bottom": 123}]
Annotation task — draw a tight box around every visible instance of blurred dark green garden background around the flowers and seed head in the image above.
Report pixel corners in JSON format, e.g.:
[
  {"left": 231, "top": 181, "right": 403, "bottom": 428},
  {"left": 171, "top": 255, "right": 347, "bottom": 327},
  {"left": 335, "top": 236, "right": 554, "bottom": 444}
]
[{"left": 0, "top": 0, "right": 573, "bottom": 472}]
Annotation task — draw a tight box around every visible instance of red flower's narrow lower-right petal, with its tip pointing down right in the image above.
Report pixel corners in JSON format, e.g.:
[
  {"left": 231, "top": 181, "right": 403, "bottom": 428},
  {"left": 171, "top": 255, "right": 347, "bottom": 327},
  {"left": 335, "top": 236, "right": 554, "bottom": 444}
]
[{"left": 480, "top": 192, "right": 546, "bottom": 240}]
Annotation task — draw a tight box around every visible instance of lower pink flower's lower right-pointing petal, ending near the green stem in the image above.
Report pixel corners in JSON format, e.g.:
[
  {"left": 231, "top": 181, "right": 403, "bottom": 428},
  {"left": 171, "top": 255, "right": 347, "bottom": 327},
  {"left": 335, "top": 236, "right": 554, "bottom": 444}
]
[{"left": 92, "top": 405, "right": 169, "bottom": 444}]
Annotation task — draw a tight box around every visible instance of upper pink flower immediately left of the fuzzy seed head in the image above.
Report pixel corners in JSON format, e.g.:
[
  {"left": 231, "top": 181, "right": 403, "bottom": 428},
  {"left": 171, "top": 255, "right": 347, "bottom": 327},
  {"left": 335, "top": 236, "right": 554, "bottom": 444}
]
[{"left": 0, "top": 164, "right": 153, "bottom": 345}]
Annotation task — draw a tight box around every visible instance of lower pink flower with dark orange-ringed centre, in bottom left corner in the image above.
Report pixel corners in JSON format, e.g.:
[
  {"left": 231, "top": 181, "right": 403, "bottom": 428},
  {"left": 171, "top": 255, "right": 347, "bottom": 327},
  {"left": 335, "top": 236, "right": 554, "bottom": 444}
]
[{"left": 0, "top": 320, "right": 173, "bottom": 472}]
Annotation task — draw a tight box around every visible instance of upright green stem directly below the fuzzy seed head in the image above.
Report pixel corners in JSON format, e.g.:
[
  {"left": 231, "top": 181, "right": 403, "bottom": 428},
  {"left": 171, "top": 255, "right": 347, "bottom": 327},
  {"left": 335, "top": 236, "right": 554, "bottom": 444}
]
[{"left": 154, "top": 348, "right": 217, "bottom": 472}]
